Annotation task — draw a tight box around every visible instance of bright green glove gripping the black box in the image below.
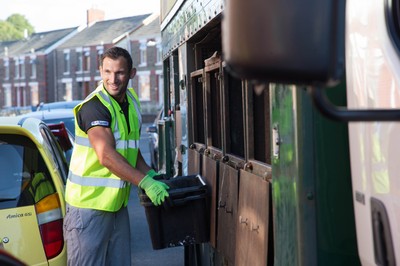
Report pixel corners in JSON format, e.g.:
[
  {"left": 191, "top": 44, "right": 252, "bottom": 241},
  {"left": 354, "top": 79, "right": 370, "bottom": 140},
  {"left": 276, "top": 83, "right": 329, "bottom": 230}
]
[{"left": 139, "top": 169, "right": 169, "bottom": 206}]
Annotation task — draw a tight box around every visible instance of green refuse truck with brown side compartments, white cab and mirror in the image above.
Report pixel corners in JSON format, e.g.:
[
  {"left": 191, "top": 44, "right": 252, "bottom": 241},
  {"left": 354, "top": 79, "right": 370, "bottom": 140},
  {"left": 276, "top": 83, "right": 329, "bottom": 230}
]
[{"left": 157, "top": 0, "right": 400, "bottom": 266}]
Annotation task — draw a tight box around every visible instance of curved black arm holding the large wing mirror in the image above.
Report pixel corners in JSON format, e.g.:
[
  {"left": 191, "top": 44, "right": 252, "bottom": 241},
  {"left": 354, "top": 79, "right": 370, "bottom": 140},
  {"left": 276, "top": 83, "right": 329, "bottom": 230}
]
[{"left": 308, "top": 86, "right": 400, "bottom": 122}]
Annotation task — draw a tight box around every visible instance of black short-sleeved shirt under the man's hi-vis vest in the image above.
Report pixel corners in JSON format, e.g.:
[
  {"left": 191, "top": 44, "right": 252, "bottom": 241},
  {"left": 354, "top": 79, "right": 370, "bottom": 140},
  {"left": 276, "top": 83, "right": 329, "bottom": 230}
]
[{"left": 77, "top": 97, "right": 130, "bottom": 133}]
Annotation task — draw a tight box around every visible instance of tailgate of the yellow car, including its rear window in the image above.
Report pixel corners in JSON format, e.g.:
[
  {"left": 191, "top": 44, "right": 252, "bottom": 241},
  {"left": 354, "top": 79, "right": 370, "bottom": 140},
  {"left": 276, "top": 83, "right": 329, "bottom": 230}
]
[{"left": 0, "top": 132, "right": 48, "bottom": 265}]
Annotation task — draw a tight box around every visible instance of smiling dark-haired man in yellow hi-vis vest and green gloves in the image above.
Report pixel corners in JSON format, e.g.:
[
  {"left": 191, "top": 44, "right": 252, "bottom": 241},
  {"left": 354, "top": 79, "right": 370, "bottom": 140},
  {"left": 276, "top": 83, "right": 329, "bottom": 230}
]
[{"left": 64, "top": 47, "right": 169, "bottom": 265}]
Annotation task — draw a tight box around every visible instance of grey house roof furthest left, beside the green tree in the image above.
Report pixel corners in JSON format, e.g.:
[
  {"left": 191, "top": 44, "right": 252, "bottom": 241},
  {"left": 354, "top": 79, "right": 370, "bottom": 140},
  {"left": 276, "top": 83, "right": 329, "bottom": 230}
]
[{"left": 0, "top": 27, "right": 78, "bottom": 57}]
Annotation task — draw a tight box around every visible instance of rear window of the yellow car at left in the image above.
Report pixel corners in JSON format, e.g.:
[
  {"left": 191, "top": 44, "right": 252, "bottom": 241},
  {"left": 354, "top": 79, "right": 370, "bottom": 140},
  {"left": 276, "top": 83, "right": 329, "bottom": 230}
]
[{"left": 0, "top": 134, "right": 56, "bottom": 209}]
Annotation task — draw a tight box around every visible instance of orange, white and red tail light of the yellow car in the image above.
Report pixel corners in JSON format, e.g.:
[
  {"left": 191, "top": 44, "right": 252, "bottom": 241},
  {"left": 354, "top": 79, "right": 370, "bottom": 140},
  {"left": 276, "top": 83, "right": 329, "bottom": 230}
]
[{"left": 35, "top": 193, "right": 64, "bottom": 259}]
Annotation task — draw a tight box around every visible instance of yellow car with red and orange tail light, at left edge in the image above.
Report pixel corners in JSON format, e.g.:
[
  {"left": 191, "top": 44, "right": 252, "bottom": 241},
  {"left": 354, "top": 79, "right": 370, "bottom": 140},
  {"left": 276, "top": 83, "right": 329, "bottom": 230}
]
[{"left": 0, "top": 117, "right": 68, "bottom": 265}]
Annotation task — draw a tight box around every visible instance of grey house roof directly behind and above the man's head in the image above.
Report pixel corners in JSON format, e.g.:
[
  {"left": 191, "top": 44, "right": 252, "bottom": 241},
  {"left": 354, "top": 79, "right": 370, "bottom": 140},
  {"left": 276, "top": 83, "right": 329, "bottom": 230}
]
[{"left": 58, "top": 14, "right": 149, "bottom": 49}]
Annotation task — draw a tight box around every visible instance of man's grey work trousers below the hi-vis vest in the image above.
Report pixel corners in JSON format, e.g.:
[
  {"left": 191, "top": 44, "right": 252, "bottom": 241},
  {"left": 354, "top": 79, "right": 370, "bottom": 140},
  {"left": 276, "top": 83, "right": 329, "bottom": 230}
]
[{"left": 64, "top": 204, "right": 131, "bottom": 266}]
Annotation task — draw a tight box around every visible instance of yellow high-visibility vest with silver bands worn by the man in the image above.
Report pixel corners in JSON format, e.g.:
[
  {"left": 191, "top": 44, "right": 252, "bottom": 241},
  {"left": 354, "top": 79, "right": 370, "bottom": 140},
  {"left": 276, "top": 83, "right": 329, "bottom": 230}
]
[{"left": 65, "top": 84, "right": 142, "bottom": 212}]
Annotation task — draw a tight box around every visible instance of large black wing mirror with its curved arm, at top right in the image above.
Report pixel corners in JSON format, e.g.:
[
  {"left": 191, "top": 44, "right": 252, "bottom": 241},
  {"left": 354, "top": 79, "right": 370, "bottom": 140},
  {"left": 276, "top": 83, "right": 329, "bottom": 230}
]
[{"left": 222, "top": 0, "right": 400, "bottom": 121}]
